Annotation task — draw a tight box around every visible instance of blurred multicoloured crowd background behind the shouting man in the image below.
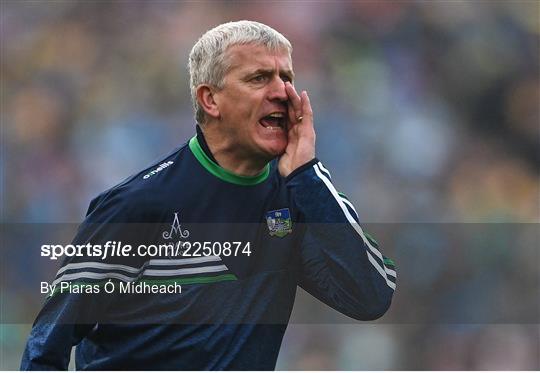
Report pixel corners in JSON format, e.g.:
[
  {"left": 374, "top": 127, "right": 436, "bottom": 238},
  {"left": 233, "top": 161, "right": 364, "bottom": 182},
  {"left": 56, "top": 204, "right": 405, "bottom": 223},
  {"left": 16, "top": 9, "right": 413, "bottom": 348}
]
[{"left": 0, "top": 0, "right": 540, "bottom": 370}]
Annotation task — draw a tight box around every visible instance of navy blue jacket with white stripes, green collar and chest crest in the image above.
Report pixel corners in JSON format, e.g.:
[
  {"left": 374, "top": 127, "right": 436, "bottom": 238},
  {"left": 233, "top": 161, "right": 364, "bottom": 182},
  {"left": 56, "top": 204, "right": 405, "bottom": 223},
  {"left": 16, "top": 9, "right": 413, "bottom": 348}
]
[{"left": 21, "top": 132, "right": 396, "bottom": 370}]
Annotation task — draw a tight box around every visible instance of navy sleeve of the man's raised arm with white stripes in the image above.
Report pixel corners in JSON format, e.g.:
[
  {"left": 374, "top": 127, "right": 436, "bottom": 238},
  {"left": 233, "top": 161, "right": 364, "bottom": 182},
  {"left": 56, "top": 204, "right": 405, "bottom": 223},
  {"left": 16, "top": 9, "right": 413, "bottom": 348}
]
[{"left": 286, "top": 159, "right": 396, "bottom": 320}]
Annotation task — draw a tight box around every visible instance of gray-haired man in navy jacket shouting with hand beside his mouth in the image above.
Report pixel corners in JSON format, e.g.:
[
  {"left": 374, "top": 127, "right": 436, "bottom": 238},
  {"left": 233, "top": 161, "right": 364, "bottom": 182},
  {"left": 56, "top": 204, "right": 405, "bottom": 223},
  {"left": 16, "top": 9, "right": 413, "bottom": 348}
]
[{"left": 22, "top": 21, "right": 396, "bottom": 370}]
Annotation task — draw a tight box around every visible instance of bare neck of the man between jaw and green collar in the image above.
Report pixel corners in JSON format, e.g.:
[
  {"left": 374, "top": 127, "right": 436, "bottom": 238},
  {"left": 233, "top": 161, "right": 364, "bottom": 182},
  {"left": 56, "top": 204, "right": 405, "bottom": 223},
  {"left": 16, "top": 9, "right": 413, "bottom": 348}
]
[{"left": 199, "top": 125, "right": 269, "bottom": 176}]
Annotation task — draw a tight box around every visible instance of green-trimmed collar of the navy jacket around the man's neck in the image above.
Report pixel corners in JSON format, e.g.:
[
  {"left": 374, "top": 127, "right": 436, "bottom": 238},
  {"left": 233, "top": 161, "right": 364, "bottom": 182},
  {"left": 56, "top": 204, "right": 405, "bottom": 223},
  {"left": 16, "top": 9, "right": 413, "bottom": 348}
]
[{"left": 189, "top": 136, "right": 270, "bottom": 185}]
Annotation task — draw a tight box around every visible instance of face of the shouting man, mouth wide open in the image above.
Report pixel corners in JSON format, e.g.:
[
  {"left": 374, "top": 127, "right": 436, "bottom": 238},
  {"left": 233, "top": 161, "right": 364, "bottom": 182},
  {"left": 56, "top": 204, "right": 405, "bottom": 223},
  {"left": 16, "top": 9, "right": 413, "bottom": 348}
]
[{"left": 214, "top": 44, "right": 293, "bottom": 161}]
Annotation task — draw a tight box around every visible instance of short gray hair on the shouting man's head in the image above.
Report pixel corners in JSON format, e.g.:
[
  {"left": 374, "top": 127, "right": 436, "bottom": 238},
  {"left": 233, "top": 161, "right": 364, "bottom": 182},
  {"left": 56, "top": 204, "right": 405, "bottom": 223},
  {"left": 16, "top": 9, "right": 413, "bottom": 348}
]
[{"left": 188, "top": 21, "right": 292, "bottom": 124}]
